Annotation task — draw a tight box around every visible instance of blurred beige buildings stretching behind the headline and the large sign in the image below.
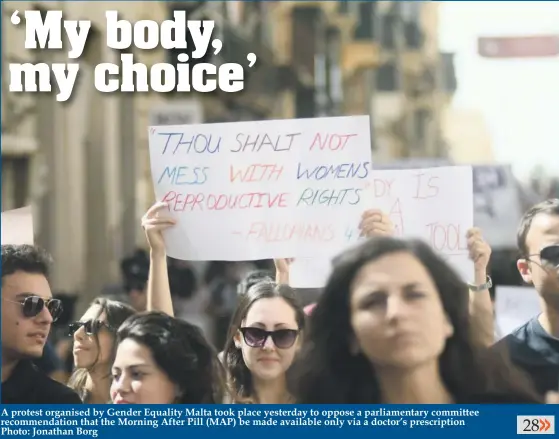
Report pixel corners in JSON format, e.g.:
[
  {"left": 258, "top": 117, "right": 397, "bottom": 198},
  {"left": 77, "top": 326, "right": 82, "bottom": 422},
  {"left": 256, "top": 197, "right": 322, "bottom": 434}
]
[{"left": 2, "top": 1, "right": 455, "bottom": 312}]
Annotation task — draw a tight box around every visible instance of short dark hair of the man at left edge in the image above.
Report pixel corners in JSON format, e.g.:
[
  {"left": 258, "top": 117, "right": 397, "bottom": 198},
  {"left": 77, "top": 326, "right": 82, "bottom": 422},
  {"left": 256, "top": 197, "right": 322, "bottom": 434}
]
[{"left": 2, "top": 244, "right": 52, "bottom": 279}]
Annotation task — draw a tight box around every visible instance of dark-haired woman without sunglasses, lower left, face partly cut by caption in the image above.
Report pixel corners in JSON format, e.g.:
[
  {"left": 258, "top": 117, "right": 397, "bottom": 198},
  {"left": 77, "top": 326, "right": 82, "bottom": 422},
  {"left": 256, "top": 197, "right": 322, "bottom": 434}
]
[{"left": 111, "top": 312, "right": 225, "bottom": 404}]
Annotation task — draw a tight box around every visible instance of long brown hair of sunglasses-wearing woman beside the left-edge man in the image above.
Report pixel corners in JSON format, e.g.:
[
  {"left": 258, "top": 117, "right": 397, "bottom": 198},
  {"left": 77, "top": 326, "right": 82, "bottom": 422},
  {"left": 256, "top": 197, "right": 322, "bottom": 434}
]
[{"left": 68, "top": 297, "right": 136, "bottom": 401}]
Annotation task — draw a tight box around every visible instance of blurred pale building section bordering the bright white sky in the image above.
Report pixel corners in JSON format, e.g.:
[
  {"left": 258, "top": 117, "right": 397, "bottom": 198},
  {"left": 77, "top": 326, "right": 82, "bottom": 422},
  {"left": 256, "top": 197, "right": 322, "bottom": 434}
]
[{"left": 372, "top": 1, "right": 456, "bottom": 162}]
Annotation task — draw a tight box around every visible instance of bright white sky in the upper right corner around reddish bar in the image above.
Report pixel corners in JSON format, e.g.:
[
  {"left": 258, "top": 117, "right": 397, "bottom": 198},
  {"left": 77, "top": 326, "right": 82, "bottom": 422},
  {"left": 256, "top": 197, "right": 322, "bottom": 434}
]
[{"left": 439, "top": 1, "right": 559, "bottom": 180}]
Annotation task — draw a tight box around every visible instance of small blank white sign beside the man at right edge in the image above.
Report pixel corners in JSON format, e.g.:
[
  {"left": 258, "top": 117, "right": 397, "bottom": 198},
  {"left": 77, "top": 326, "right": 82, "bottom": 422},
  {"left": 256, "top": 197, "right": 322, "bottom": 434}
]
[{"left": 495, "top": 285, "right": 542, "bottom": 339}]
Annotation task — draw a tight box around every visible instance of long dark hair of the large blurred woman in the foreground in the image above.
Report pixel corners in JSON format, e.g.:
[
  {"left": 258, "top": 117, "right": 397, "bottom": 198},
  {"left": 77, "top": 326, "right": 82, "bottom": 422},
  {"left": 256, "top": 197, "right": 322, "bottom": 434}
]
[{"left": 295, "top": 238, "right": 537, "bottom": 404}]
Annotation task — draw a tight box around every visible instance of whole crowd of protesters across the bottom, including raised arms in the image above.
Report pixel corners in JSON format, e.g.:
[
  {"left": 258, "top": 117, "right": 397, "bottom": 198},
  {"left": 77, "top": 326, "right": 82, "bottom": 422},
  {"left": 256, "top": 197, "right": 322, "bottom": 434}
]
[{"left": 1, "top": 199, "right": 559, "bottom": 404}]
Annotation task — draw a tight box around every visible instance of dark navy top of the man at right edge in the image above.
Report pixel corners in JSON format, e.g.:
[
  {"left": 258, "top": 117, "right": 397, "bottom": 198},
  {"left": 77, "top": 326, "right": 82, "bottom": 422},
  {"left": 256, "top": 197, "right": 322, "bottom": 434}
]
[{"left": 494, "top": 317, "right": 559, "bottom": 395}]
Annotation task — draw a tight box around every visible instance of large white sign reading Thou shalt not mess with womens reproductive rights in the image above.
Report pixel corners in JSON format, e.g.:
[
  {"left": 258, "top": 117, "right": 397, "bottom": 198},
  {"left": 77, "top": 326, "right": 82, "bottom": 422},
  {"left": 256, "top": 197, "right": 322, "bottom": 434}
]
[{"left": 149, "top": 116, "right": 371, "bottom": 261}]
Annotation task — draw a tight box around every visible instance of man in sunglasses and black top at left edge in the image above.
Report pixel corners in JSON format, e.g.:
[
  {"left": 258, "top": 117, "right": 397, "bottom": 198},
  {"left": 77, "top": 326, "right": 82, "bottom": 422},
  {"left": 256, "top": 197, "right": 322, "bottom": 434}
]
[{"left": 1, "top": 245, "right": 81, "bottom": 404}]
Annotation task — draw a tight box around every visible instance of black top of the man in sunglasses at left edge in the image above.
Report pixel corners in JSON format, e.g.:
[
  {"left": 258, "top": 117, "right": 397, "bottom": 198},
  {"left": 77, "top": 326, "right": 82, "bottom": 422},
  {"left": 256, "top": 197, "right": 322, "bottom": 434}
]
[{"left": 2, "top": 360, "right": 82, "bottom": 404}]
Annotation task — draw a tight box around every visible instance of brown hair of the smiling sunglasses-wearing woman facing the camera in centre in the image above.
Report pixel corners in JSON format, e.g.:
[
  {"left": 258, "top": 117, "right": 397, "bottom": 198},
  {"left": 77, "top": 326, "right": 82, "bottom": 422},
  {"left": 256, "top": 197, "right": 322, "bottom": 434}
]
[{"left": 223, "top": 280, "right": 305, "bottom": 401}]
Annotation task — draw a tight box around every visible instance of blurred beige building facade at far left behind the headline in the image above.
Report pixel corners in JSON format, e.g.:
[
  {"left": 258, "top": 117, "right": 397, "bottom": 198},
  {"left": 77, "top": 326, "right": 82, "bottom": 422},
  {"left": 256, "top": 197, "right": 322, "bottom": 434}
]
[{"left": 2, "top": 1, "right": 170, "bottom": 310}]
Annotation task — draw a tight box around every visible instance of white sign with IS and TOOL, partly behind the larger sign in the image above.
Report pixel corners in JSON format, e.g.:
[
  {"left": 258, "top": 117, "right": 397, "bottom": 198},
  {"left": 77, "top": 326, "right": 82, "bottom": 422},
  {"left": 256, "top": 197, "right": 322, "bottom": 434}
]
[{"left": 290, "top": 166, "right": 474, "bottom": 288}]
